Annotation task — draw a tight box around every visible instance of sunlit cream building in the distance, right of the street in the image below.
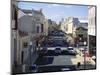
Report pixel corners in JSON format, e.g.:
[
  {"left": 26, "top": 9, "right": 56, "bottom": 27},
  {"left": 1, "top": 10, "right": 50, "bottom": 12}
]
[{"left": 61, "top": 17, "right": 79, "bottom": 34}]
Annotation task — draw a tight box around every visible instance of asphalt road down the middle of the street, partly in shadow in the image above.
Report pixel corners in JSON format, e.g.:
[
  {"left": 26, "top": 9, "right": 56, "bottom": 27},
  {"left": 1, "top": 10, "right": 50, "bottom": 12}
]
[{"left": 29, "top": 32, "right": 95, "bottom": 72}]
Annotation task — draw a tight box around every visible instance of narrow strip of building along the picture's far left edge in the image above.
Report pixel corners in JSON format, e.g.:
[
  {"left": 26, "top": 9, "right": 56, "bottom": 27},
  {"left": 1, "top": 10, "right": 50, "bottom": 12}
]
[{"left": 11, "top": 0, "right": 18, "bottom": 73}]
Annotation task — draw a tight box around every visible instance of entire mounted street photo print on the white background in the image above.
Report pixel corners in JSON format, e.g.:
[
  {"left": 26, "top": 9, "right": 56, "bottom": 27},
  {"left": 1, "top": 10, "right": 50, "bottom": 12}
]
[{"left": 11, "top": 1, "right": 96, "bottom": 74}]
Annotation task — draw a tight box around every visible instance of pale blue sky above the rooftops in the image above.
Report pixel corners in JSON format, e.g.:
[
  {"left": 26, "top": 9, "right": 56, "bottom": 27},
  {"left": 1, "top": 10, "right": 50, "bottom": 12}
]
[{"left": 18, "top": 2, "right": 88, "bottom": 23}]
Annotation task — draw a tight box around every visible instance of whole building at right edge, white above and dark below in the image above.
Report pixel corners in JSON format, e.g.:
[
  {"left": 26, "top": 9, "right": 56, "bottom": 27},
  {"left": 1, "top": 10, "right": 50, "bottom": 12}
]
[{"left": 88, "top": 6, "right": 96, "bottom": 56}]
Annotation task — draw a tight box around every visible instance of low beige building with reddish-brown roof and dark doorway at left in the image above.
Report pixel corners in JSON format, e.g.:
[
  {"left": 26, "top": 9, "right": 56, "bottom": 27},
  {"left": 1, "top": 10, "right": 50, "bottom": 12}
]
[{"left": 18, "top": 31, "right": 30, "bottom": 64}]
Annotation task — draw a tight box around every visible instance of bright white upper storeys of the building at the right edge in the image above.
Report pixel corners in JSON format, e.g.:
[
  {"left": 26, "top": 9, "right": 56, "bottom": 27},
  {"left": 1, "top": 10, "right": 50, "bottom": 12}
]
[{"left": 88, "top": 6, "right": 96, "bottom": 36}]
